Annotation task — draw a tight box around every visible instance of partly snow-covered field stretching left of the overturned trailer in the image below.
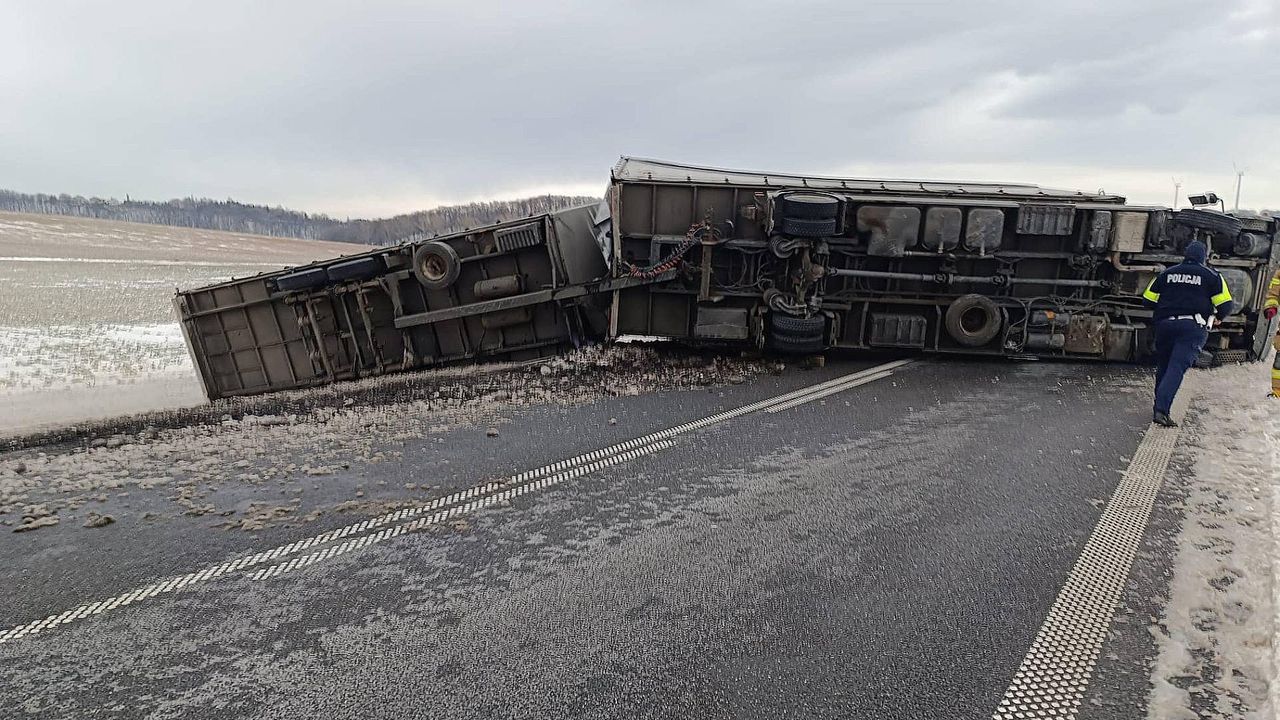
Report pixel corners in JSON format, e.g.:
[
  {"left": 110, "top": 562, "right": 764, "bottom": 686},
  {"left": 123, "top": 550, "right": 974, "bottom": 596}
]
[{"left": 0, "top": 213, "right": 371, "bottom": 436}]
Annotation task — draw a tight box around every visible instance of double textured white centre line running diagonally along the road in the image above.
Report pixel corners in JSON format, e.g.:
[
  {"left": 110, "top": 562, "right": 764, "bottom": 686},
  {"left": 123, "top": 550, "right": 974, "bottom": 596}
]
[{"left": 0, "top": 360, "right": 913, "bottom": 644}]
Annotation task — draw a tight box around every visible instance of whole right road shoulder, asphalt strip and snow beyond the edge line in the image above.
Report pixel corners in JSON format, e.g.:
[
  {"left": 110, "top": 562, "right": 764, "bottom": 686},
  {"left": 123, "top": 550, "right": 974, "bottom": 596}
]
[{"left": 1082, "top": 364, "right": 1280, "bottom": 720}]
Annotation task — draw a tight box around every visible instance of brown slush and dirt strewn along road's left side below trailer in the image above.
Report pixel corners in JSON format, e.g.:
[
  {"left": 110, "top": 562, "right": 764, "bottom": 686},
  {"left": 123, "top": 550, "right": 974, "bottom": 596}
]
[{"left": 0, "top": 345, "right": 781, "bottom": 532}]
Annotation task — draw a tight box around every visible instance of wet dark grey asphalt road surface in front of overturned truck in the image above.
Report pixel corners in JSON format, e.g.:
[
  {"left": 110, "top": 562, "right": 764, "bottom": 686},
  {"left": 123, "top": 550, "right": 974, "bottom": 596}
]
[{"left": 0, "top": 363, "right": 1172, "bottom": 719}]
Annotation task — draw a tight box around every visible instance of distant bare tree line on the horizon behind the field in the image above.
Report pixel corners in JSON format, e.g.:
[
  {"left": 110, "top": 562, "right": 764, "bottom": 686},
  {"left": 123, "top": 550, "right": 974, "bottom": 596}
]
[{"left": 0, "top": 190, "right": 596, "bottom": 245}]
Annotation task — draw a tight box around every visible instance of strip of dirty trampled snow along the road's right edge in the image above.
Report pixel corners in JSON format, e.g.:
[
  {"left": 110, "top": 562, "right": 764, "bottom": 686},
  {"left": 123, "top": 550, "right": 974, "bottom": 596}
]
[{"left": 1148, "top": 363, "right": 1280, "bottom": 720}]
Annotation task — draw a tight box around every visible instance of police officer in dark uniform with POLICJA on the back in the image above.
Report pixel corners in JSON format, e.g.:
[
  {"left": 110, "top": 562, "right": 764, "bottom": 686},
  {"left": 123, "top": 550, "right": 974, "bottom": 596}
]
[{"left": 1142, "top": 240, "right": 1231, "bottom": 428}]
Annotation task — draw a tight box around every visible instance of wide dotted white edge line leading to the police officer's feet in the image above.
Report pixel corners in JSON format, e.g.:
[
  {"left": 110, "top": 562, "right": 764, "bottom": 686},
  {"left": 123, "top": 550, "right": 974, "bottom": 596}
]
[{"left": 992, "top": 378, "right": 1194, "bottom": 720}]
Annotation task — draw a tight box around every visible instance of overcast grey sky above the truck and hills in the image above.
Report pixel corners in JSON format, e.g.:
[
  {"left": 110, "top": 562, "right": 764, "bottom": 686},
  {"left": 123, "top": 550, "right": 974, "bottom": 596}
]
[{"left": 0, "top": 0, "right": 1280, "bottom": 217}]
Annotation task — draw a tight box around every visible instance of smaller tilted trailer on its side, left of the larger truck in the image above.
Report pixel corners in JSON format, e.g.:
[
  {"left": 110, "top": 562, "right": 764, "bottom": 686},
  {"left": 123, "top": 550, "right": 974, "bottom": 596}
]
[{"left": 174, "top": 208, "right": 607, "bottom": 400}]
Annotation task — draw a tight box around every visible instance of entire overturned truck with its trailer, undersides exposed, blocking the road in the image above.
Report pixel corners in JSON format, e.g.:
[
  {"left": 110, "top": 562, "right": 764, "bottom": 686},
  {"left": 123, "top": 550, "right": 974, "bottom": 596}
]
[{"left": 174, "top": 158, "right": 1280, "bottom": 398}]
